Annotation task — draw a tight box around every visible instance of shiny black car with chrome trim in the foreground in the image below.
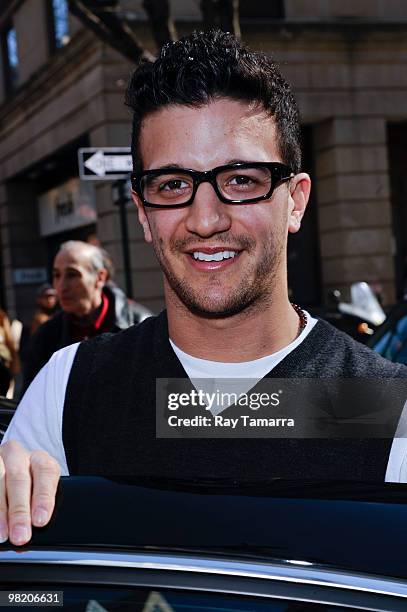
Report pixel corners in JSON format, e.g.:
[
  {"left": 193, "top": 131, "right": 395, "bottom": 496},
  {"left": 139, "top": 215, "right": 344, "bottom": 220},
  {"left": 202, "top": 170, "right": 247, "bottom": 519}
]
[{"left": 0, "top": 477, "right": 407, "bottom": 612}]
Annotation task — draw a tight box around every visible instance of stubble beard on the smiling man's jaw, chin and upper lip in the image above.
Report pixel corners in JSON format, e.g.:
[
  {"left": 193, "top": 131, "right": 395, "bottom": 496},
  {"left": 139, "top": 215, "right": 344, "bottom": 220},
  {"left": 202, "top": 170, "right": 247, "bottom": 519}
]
[{"left": 154, "top": 236, "right": 286, "bottom": 319}]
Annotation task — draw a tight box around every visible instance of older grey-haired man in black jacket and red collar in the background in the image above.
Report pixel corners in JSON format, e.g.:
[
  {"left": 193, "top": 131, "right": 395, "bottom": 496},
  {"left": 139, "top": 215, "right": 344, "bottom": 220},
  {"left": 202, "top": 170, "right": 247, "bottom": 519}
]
[{"left": 24, "top": 240, "right": 151, "bottom": 389}]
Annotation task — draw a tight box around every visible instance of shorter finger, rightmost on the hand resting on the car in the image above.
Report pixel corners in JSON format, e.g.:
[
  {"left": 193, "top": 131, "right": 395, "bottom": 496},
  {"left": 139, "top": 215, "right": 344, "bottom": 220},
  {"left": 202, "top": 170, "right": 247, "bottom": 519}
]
[{"left": 31, "top": 450, "right": 60, "bottom": 527}]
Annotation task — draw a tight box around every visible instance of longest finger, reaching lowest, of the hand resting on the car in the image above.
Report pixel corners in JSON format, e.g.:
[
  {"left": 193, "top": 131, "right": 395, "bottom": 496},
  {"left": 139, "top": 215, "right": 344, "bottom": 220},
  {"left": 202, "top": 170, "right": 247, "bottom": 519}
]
[{"left": 1, "top": 441, "right": 31, "bottom": 546}]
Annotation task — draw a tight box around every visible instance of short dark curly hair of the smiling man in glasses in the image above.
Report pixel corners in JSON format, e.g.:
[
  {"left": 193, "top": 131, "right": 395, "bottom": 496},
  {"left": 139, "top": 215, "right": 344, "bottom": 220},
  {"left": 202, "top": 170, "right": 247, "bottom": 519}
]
[{"left": 126, "top": 30, "right": 301, "bottom": 173}]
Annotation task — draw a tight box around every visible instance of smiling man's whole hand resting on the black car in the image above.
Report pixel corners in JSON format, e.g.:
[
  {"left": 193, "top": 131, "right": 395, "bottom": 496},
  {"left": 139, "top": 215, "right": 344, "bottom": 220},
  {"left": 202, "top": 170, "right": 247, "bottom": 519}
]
[{"left": 0, "top": 440, "right": 60, "bottom": 546}]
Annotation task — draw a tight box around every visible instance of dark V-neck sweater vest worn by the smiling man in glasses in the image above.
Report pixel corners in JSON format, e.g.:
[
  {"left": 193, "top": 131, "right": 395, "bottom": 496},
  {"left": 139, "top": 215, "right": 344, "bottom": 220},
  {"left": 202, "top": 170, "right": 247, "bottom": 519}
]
[{"left": 63, "top": 312, "right": 407, "bottom": 481}]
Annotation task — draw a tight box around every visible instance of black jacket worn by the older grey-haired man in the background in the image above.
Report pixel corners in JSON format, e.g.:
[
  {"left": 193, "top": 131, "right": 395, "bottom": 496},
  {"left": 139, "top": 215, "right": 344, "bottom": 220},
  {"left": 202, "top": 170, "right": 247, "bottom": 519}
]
[{"left": 23, "top": 286, "right": 152, "bottom": 391}]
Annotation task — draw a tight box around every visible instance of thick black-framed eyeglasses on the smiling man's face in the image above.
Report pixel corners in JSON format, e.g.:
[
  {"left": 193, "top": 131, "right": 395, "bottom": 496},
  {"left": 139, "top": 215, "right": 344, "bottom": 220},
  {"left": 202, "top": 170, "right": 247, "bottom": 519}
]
[{"left": 131, "top": 162, "right": 294, "bottom": 208}]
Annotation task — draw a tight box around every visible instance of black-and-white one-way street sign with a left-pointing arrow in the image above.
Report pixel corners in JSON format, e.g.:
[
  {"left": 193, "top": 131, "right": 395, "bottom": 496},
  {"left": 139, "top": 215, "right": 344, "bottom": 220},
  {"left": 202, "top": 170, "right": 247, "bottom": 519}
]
[{"left": 78, "top": 147, "right": 133, "bottom": 181}]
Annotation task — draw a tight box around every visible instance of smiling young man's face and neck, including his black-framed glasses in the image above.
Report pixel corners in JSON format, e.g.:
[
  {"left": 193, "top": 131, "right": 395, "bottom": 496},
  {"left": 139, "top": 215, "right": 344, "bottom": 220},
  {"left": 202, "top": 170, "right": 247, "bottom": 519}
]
[{"left": 133, "top": 97, "right": 310, "bottom": 352}]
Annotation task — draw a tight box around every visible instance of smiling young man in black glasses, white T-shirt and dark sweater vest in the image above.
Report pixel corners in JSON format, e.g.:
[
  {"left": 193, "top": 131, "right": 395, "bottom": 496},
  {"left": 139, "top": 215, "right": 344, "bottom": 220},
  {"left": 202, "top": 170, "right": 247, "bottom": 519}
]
[{"left": 0, "top": 32, "right": 407, "bottom": 544}]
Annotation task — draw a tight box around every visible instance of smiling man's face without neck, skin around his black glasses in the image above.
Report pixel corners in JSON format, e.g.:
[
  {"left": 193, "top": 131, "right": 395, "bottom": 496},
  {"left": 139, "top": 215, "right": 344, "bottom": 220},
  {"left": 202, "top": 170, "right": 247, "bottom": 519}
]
[{"left": 135, "top": 98, "right": 305, "bottom": 316}]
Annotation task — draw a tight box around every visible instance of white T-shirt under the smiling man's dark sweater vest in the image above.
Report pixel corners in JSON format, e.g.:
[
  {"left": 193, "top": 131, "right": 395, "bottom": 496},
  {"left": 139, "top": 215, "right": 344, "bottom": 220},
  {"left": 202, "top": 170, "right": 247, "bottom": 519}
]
[{"left": 3, "top": 315, "right": 407, "bottom": 482}]
